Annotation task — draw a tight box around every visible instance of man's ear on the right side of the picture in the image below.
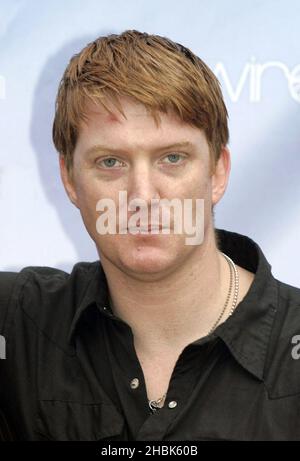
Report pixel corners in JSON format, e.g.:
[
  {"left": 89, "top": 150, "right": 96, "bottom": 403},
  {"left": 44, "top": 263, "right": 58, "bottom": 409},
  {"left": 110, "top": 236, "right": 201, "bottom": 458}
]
[{"left": 211, "top": 147, "right": 231, "bottom": 205}]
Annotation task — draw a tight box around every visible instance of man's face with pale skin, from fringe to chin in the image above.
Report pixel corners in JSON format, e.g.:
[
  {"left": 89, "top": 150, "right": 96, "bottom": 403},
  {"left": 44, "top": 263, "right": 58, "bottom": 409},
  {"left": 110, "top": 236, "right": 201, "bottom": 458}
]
[{"left": 61, "top": 98, "right": 230, "bottom": 280}]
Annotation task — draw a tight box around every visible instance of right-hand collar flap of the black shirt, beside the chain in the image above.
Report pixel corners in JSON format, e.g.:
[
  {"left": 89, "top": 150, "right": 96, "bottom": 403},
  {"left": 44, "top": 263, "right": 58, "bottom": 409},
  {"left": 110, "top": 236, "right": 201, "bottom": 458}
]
[{"left": 214, "top": 229, "right": 278, "bottom": 380}]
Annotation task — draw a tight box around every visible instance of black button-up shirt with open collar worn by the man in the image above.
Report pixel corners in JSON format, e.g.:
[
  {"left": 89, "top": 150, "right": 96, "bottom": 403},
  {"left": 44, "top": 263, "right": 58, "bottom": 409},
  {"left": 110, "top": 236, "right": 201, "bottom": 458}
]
[{"left": 0, "top": 229, "right": 300, "bottom": 441}]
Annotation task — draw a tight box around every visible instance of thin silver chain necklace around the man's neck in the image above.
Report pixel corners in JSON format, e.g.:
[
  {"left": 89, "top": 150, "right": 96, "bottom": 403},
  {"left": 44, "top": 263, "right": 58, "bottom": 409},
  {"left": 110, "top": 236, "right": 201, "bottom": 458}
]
[{"left": 148, "top": 251, "right": 240, "bottom": 413}]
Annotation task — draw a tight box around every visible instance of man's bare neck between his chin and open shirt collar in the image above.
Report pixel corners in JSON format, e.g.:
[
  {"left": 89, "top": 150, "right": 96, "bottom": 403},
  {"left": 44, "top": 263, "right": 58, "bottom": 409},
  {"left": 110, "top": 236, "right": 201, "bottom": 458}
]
[{"left": 101, "top": 226, "right": 230, "bottom": 355}]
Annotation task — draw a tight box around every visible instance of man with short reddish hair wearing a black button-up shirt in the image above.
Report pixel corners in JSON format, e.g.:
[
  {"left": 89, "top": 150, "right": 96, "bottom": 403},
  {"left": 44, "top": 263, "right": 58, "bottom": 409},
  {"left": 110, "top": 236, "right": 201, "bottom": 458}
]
[{"left": 0, "top": 30, "right": 300, "bottom": 440}]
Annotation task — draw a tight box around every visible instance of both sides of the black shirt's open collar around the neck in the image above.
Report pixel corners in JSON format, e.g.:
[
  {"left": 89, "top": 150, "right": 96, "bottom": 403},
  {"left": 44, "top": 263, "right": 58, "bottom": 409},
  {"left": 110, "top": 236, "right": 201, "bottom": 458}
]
[{"left": 68, "top": 229, "right": 278, "bottom": 380}]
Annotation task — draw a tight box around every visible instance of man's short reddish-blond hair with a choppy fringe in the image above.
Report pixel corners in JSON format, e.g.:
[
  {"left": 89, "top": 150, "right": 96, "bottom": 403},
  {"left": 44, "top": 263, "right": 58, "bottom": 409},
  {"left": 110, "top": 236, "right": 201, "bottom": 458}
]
[{"left": 53, "top": 30, "right": 229, "bottom": 174}]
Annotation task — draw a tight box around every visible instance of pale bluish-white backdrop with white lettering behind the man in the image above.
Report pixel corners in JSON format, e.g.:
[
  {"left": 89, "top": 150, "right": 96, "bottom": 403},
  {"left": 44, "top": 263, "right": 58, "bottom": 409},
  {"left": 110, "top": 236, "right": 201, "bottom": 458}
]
[{"left": 0, "top": 0, "right": 300, "bottom": 287}]
